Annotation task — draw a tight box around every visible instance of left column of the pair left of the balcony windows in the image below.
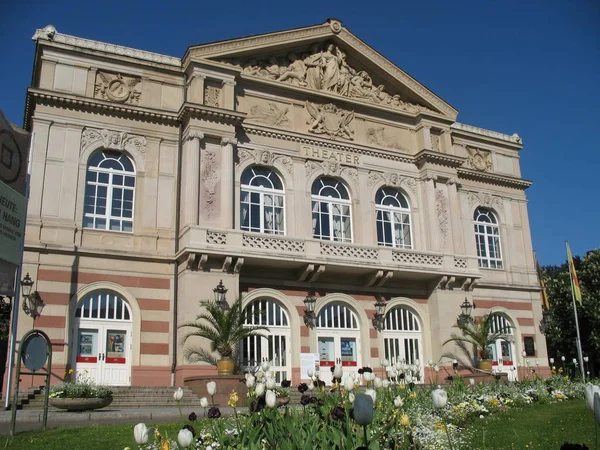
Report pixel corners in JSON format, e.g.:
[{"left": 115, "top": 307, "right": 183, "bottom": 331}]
[{"left": 181, "top": 131, "right": 204, "bottom": 226}]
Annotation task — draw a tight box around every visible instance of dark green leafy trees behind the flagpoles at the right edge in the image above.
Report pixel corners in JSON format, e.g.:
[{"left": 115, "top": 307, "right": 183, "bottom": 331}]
[{"left": 542, "top": 249, "right": 600, "bottom": 377}]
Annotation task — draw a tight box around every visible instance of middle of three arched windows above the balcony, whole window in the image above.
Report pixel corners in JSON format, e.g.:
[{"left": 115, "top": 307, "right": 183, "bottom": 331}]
[{"left": 312, "top": 177, "right": 352, "bottom": 242}]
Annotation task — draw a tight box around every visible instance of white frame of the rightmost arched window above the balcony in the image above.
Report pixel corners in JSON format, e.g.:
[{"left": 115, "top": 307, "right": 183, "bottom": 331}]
[{"left": 375, "top": 187, "right": 413, "bottom": 250}]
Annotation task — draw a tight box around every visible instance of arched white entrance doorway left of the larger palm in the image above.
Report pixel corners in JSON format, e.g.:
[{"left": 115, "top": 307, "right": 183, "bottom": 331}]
[{"left": 72, "top": 291, "right": 132, "bottom": 386}]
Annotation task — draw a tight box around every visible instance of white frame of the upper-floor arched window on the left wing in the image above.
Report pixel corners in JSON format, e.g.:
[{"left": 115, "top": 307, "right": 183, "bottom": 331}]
[{"left": 83, "top": 150, "right": 136, "bottom": 233}]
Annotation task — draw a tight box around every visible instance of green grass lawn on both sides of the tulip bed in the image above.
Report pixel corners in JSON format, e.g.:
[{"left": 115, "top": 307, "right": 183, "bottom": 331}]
[{"left": 0, "top": 400, "right": 595, "bottom": 450}]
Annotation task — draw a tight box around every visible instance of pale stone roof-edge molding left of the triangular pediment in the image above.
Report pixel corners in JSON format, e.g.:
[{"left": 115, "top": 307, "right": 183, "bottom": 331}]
[{"left": 31, "top": 25, "right": 181, "bottom": 67}]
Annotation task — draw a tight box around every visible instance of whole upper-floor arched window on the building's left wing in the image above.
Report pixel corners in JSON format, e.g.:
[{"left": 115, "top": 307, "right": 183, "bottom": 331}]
[{"left": 83, "top": 150, "right": 135, "bottom": 232}]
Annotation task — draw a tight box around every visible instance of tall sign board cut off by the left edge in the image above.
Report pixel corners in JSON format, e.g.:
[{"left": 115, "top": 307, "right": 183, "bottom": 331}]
[{"left": 0, "top": 111, "right": 30, "bottom": 297}]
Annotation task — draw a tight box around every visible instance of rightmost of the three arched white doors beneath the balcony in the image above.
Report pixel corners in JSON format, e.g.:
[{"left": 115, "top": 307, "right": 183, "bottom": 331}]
[{"left": 383, "top": 306, "right": 423, "bottom": 372}]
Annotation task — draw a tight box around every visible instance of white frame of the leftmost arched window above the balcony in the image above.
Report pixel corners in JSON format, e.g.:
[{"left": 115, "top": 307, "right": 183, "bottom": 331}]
[{"left": 240, "top": 166, "right": 286, "bottom": 235}]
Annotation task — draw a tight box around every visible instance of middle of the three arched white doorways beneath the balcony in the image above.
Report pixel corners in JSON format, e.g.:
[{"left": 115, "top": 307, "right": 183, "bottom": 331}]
[{"left": 316, "top": 303, "right": 360, "bottom": 384}]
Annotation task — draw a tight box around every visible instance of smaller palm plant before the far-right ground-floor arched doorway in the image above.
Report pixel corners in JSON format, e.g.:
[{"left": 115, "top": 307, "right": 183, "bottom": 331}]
[{"left": 442, "top": 313, "right": 510, "bottom": 370}]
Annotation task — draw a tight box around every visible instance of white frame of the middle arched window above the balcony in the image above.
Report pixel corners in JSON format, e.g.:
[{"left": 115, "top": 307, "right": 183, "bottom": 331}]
[{"left": 311, "top": 177, "right": 354, "bottom": 243}]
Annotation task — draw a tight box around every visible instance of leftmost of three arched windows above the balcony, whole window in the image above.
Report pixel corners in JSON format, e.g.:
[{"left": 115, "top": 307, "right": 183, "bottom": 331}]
[{"left": 240, "top": 166, "right": 285, "bottom": 234}]
